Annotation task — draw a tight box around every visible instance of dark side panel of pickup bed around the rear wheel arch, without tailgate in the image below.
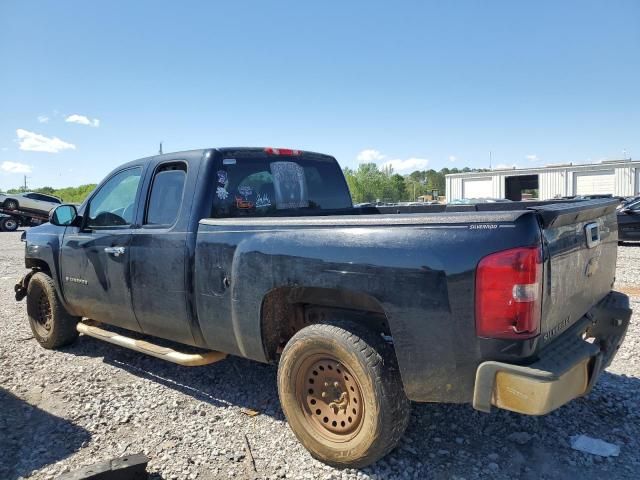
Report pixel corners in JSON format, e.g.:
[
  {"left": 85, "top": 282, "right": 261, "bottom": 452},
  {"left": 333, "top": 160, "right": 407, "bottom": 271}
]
[{"left": 195, "top": 212, "right": 540, "bottom": 402}]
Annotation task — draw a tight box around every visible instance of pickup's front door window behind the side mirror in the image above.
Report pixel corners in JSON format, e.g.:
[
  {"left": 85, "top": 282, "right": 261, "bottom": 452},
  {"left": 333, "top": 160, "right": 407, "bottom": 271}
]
[{"left": 86, "top": 167, "right": 142, "bottom": 228}]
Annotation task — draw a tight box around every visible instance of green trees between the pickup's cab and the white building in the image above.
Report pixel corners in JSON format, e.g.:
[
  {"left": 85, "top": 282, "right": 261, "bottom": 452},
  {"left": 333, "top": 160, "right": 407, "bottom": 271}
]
[{"left": 343, "top": 163, "right": 487, "bottom": 203}]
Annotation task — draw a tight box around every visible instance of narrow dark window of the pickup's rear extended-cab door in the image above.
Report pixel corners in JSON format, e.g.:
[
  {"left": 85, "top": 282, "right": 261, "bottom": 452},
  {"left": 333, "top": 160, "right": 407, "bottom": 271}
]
[{"left": 144, "top": 162, "right": 187, "bottom": 226}]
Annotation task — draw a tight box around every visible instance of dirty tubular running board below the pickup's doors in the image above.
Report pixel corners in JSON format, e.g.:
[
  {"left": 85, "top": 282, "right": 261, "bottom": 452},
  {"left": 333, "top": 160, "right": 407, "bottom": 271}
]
[{"left": 76, "top": 322, "right": 227, "bottom": 367}]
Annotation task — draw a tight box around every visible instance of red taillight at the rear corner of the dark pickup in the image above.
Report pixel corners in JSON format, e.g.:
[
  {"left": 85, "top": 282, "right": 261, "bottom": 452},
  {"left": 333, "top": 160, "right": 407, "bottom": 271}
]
[{"left": 476, "top": 247, "right": 542, "bottom": 339}]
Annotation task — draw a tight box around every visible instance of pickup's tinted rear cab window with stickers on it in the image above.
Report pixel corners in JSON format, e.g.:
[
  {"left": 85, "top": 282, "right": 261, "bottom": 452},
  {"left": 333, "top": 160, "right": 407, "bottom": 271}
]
[{"left": 212, "top": 155, "right": 352, "bottom": 218}]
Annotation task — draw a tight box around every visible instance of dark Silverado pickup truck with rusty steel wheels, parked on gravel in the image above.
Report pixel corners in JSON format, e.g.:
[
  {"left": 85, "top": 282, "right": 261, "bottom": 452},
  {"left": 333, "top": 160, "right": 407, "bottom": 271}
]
[{"left": 16, "top": 148, "right": 631, "bottom": 467}]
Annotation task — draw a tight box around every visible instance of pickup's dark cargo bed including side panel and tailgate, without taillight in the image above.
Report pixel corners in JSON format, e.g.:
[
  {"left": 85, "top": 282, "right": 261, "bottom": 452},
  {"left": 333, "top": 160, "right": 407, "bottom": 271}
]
[{"left": 195, "top": 200, "right": 617, "bottom": 402}]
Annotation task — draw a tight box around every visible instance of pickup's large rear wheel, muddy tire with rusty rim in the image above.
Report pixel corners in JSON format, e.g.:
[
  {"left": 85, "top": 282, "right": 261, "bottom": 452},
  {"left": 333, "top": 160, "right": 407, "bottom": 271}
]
[{"left": 278, "top": 321, "right": 411, "bottom": 468}]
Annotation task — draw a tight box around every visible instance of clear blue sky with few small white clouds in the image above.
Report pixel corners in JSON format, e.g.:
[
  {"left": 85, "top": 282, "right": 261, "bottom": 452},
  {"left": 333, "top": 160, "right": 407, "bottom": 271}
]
[{"left": 0, "top": 0, "right": 640, "bottom": 189}]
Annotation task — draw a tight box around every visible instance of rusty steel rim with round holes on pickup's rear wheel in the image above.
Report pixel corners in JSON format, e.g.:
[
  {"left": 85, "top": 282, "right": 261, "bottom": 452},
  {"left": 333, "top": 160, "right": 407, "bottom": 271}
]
[{"left": 295, "top": 354, "right": 364, "bottom": 442}]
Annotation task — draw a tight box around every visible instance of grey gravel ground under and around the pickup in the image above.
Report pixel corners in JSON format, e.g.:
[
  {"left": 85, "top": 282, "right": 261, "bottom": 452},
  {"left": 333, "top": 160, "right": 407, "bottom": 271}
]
[{"left": 0, "top": 232, "right": 640, "bottom": 479}]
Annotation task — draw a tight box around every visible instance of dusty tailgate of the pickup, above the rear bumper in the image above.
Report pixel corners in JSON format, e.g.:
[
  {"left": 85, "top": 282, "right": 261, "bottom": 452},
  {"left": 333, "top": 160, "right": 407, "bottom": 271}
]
[{"left": 532, "top": 199, "right": 618, "bottom": 347}]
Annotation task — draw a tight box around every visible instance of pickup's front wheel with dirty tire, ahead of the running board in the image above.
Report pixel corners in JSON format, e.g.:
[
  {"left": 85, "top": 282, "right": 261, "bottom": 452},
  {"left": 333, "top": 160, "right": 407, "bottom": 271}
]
[{"left": 27, "top": 272, "right": 79, "bottom": 349}]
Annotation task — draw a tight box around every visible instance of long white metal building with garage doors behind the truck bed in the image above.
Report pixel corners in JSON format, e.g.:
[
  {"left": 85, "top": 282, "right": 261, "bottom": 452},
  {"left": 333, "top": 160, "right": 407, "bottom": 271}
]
[{"left": 446, "top": 160, "right": 640, "bottom": 202}]
